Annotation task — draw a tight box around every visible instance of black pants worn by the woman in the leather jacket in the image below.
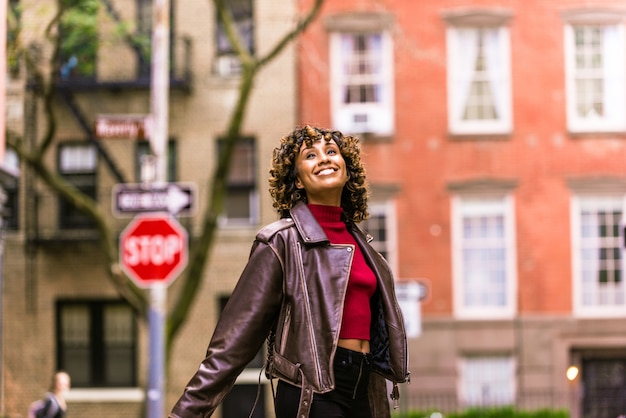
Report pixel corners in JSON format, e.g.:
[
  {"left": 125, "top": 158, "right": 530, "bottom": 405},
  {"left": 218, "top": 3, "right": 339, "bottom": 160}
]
[{"left": 275, "top": 347, "right": 372, "bottom": 418}]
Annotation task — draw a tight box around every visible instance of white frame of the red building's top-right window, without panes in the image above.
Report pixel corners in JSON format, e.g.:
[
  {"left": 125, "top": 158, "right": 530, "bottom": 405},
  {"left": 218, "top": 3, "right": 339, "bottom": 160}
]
[{"left": 564, "top": 19, "right": 626, "bottom": 133}]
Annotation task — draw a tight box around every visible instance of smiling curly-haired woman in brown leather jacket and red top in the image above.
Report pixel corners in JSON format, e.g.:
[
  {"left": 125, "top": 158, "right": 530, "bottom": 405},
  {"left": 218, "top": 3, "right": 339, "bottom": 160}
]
[{"left": 170, "top": 126, "right": 409, "bottom": 418}]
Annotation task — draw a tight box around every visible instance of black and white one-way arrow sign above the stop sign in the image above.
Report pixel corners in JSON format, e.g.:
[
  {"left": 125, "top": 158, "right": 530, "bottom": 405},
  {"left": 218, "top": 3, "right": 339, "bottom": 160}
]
[{"left": 113, "top": 183, "right": 196, "bottom": 216}]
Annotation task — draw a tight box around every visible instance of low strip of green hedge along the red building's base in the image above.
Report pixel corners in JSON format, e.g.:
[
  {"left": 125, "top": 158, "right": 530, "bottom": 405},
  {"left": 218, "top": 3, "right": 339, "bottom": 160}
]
[{"left": 392, "top": 406, "right": 569, "bottom": 418}]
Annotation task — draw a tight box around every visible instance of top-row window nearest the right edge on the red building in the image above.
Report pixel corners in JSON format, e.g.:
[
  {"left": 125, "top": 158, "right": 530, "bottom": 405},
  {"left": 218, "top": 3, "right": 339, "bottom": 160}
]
[{"left": 565, "top": 15, "right": 626, "bottom": 132}]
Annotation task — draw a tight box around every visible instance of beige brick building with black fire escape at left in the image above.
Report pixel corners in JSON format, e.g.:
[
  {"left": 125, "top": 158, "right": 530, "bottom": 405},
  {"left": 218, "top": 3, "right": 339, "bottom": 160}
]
[{"left": 0, "top": 0, "right": 297, "bottom": 418}]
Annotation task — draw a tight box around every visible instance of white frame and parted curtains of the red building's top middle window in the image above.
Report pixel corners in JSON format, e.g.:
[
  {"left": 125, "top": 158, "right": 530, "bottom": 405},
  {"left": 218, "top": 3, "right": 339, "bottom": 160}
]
[{"left": 446, "top": 25, "right": 513, "bottom": 135}]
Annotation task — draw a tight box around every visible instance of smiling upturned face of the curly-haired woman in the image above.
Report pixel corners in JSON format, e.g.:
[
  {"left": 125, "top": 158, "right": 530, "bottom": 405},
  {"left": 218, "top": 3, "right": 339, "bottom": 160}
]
[{"left": 296, "top": 138, "right": 348, "bottom": 206}]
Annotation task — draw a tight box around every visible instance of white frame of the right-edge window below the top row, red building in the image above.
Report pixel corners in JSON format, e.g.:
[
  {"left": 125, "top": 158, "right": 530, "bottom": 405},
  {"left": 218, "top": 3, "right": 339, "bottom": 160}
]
[{"left": 570, "top": 194, "right": 626, "bottom": 318}]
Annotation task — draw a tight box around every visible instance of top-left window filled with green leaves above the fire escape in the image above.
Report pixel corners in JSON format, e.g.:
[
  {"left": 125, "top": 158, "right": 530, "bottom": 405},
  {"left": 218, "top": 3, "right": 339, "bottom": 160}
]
[{"left": 59, "top": 0, "right": 99, "bottom": 80}]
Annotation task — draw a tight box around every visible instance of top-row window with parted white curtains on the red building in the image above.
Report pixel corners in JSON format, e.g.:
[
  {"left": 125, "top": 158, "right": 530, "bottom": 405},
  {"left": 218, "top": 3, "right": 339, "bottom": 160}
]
[{"left": 447, "top": 26, "right": 512, "bottom": 135}]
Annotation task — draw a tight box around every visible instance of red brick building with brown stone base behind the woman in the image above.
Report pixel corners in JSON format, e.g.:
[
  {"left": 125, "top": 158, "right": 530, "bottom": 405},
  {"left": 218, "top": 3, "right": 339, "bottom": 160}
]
[{"left": 297, "top": 0, "right": 626, "bottom": 417}]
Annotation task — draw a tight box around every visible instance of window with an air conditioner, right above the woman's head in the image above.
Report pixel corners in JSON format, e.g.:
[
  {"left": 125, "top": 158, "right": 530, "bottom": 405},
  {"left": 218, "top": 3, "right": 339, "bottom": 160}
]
[{"left": 330, "top": 31, "right": 394, "bottom": 136}]
